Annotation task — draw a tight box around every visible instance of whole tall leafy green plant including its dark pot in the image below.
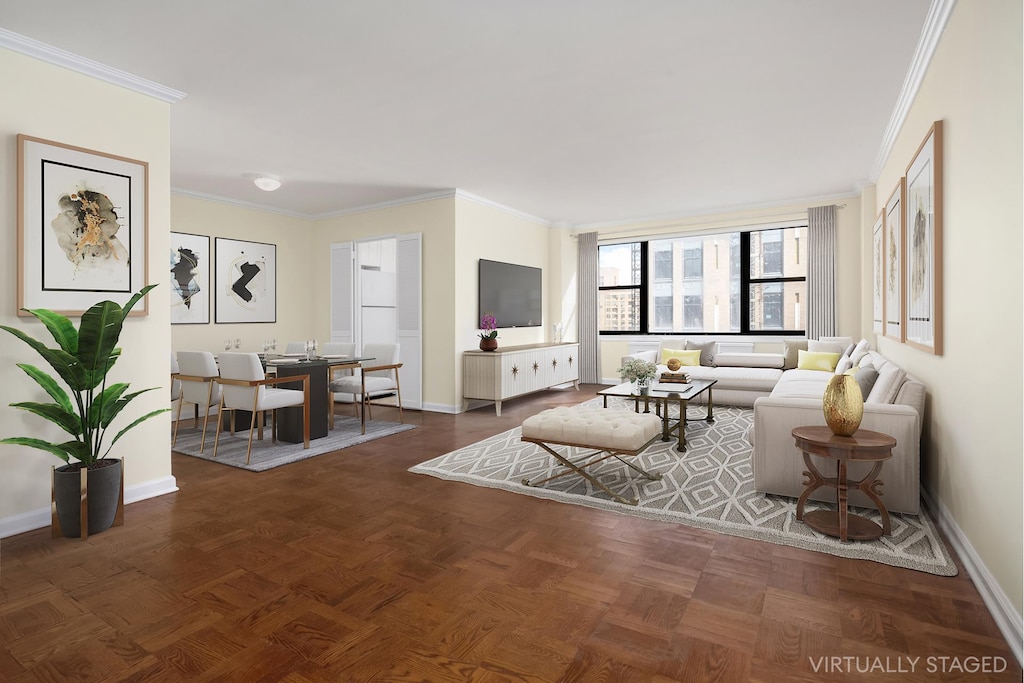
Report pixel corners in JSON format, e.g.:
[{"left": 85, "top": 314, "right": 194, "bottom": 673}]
[{"left": 0, "top": 285, "right": 170, "bottom": 538}]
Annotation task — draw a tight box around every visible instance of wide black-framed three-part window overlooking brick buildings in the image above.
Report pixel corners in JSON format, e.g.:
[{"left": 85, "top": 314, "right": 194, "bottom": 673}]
[{"left": 598, "top": 225, "right": 807, "bottom": 334}]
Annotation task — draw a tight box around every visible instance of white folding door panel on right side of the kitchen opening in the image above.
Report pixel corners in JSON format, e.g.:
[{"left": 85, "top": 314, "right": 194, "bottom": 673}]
[{"left": 397, "top": 232, "right": 423, "bottom": 409}]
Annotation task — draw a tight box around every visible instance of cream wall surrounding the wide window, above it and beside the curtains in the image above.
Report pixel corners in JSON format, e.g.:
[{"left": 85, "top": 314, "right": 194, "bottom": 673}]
[{"left": 593, "top": 197, "right": 869, "bottom": 381}]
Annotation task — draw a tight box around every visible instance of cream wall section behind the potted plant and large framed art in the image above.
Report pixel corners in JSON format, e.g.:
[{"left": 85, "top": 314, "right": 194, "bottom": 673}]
[{"left": 0, "top": 48, "right": 174, "bottom": 536}]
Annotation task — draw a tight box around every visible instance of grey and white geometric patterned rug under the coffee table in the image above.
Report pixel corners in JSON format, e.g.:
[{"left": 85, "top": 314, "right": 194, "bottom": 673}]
[{"left": 410, "top": 399, "right": 956, "bottom": 577}]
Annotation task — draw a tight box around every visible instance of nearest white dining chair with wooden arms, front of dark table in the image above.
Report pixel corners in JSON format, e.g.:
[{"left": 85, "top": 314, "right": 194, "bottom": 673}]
[{"left": 213, "top": 353, "right": 309, "bottom": 465}]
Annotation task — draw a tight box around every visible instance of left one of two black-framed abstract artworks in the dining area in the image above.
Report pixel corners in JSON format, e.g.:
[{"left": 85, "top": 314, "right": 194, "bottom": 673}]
[{"left": 169, "top": 232, "right": 212, "bottom": 325}]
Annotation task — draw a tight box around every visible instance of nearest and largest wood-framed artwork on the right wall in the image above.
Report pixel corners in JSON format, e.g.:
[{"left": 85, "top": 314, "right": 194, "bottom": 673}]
[{"left": 906, "top": 121, "right": 942, "bottom": 355}]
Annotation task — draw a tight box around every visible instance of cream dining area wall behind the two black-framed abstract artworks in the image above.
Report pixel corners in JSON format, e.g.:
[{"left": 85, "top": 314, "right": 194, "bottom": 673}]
[{"left": 169, "top": 195, "right": 313, "bottom": 353}]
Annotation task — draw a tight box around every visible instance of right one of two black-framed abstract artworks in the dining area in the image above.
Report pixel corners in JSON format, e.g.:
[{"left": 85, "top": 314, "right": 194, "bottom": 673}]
[{"left": 214, "top": 238, "right": 278, "bottom": 324}]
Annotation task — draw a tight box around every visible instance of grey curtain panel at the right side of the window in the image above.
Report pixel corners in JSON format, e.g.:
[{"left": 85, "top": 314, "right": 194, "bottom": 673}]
[{"left": 807, "top": 205, "right": 836, "bottom": 339}]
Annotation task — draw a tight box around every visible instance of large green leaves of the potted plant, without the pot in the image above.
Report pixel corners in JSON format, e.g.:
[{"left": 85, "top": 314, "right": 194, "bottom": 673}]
[{"left": 0, "top": 285, "right": 170, "bottom": 467}]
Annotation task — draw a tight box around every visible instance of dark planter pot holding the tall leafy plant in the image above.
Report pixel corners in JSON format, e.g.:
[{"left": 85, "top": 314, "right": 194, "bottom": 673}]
[{"left": 53, "top": 458, "right": 122, "bottom": 539}]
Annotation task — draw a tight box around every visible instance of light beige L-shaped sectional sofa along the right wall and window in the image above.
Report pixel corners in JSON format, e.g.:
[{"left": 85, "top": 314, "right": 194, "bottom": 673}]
[{"left": 623, "top": 340, "right": 926, "bottom": 514}]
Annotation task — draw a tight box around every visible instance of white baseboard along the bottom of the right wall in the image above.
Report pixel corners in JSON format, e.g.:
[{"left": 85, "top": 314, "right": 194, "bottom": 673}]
[{"left": 921, "top": 486, "right": 1024, "bottom": 664}]
